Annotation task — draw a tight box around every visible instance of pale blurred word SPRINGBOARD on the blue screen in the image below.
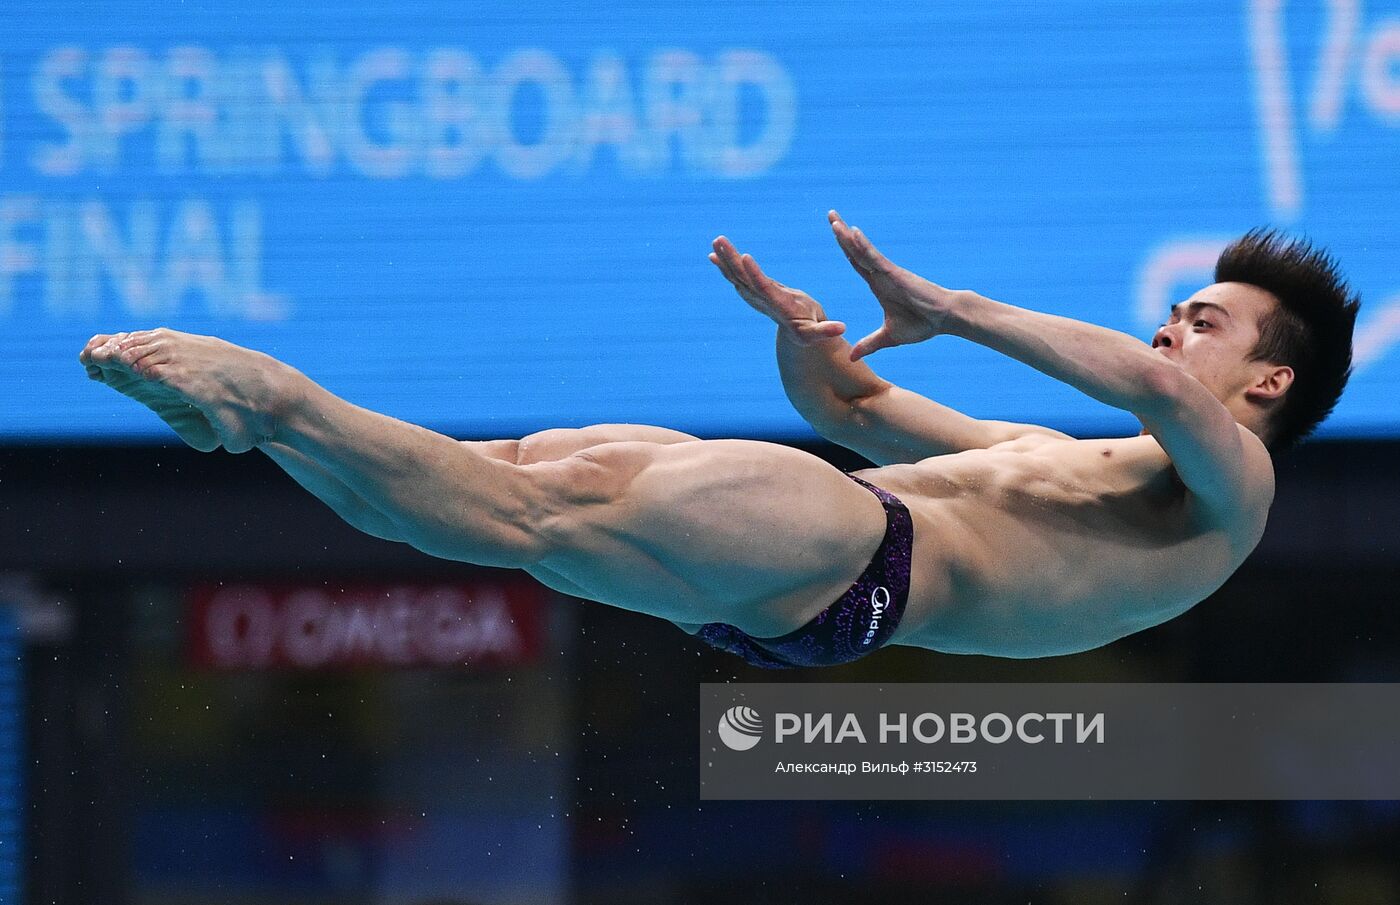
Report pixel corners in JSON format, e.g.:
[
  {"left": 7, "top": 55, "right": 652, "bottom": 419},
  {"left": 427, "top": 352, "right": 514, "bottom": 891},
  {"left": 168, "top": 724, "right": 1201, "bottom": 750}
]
[{"left": 24, "top": 45, "right": 797, "bottom": 179}]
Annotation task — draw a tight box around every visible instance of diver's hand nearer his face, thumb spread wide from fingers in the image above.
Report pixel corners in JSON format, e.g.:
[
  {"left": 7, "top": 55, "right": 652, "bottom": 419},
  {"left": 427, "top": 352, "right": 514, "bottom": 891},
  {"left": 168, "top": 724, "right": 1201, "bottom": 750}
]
[{"left": 826, "top": 210, "right": 960, "bottom": 361}]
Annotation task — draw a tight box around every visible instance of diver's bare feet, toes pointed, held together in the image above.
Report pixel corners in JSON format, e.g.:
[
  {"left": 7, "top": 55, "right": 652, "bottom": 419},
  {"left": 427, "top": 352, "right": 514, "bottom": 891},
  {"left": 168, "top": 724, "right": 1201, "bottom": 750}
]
[{"left": 78, "top": 328, "right": 295, "bottom": 453}]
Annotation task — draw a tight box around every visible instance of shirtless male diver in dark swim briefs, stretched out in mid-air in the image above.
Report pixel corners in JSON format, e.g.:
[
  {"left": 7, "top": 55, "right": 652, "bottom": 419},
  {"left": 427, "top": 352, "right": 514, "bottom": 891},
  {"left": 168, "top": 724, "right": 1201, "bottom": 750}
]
[{"left": 80, "top": 212, "right": 1359, "bottom": 667}]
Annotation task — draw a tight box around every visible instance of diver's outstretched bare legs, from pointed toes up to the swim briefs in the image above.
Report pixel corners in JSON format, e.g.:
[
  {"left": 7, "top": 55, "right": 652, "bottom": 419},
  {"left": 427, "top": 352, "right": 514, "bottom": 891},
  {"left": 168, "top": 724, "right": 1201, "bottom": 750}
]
[{"left": 81, "top": 331, "right": 885, "bottom": 635}]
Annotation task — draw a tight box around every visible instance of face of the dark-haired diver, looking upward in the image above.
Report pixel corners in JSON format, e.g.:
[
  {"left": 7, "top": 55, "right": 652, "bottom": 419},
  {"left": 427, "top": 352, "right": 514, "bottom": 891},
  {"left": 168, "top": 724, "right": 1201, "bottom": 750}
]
[{"left": 1152, "top": 283, "right": 1278, "bottom": 402}]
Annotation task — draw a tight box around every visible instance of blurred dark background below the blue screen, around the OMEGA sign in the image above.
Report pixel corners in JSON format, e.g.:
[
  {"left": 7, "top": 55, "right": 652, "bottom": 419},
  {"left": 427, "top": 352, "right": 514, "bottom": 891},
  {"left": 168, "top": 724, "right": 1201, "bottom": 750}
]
[{"left": 0, "top": 441, "right": 1400, "bottom": 905}]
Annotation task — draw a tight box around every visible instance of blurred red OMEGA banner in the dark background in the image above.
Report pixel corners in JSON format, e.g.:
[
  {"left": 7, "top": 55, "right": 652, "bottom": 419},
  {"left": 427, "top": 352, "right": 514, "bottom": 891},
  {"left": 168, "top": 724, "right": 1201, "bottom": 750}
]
[{"left": 188, "top": 580, "right": 545, "bottom": 670}]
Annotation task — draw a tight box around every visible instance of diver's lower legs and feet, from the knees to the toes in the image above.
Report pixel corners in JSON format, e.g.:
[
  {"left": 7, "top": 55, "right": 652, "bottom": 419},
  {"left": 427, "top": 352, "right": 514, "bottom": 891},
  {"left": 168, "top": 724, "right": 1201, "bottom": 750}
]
[{"left": 80, "top": 328, "right": 539, "bottom": 566}]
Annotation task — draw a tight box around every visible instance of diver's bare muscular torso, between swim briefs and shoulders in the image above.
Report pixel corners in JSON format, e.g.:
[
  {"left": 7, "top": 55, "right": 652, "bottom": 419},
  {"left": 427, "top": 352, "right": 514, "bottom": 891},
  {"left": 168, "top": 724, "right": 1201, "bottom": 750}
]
[{"left": 855, "top": 436, "right": 1267, "bottom": 657}]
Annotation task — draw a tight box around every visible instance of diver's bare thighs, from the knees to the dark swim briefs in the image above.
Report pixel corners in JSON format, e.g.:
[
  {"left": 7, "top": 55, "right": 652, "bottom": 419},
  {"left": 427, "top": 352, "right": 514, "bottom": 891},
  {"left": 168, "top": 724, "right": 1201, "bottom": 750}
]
[{"left": 523, "top": 440, "right": 886, "bottom": 637}]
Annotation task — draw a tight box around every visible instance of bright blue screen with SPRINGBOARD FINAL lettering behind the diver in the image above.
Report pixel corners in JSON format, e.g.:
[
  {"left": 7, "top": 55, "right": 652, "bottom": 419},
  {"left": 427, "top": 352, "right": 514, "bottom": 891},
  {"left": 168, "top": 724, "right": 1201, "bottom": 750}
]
[{"left": 0, "top": 0, "right": 1400, "bottom": 441}]
